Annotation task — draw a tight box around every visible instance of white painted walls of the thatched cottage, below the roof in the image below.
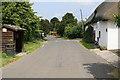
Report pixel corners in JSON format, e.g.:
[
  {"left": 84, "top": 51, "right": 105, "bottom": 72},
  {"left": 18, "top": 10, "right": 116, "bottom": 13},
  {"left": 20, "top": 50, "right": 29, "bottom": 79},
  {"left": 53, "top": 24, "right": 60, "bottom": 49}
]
[{"left": 92, "top": 21, "right": 120, "bottom": 50}]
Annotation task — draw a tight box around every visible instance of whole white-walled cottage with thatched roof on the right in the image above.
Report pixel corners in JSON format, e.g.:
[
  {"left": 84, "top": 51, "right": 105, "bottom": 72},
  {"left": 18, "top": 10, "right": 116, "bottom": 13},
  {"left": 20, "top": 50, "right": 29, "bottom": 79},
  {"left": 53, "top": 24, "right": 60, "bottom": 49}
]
[{"left": 85, "top": 1, "right": 120, "bottom": 50}]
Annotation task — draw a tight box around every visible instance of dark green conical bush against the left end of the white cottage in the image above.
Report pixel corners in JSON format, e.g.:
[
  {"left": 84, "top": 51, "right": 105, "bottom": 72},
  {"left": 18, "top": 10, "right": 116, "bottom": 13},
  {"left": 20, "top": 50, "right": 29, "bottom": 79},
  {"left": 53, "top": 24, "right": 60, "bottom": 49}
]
[{"left": 83, "top": 26, "right": 95, "bottom": 43}]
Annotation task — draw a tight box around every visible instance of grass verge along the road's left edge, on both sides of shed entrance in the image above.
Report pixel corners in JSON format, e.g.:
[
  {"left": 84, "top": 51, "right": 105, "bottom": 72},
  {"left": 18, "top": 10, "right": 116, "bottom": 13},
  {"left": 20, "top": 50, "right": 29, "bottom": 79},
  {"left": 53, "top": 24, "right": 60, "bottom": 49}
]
[{"left": 0, "top": 39, "right": 47, "bottom": 68}]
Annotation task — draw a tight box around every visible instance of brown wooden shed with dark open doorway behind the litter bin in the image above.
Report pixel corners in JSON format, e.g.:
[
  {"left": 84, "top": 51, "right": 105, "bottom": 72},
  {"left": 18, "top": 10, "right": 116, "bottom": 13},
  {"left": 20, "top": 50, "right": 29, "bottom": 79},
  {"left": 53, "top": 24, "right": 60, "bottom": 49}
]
[{"left": 2, "top": 24, "right": 25, "bottom": 52}]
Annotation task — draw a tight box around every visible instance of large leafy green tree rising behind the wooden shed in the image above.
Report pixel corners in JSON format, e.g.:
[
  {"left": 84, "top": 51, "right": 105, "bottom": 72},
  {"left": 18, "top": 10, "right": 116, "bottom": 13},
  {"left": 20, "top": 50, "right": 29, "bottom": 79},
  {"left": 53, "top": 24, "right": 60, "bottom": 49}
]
[{"left": 2, "top": 2, "right": 41, "bottom": 41}]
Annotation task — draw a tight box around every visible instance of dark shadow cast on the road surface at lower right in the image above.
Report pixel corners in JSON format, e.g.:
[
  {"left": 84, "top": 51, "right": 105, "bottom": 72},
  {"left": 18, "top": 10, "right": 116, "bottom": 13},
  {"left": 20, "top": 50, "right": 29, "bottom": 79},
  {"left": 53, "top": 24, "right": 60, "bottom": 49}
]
[{"left": 83, "top": 63, "right": 117, "bottom": 80}]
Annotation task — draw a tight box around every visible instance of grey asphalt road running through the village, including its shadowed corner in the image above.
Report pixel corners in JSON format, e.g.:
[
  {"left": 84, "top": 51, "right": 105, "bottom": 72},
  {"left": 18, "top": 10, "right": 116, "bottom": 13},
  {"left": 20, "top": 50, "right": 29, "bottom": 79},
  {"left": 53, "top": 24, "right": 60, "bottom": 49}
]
[{"left": 3, "top": 37, "right": 113, "bottom": 78}]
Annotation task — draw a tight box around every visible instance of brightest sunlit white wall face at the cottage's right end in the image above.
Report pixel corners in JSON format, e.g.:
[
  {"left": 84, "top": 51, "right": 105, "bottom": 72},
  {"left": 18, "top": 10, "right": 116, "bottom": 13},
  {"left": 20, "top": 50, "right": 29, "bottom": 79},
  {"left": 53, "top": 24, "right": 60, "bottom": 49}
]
[{"left": 107, "top": 21, "right": 120, "bottom": 50}]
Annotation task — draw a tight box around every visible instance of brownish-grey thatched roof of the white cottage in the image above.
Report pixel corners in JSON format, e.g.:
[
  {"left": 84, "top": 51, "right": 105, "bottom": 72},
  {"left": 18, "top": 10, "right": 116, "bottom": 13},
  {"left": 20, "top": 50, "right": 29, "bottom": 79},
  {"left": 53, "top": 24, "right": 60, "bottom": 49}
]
[{"left": 85, "top": 1, "right": 120, "bottom": 26}]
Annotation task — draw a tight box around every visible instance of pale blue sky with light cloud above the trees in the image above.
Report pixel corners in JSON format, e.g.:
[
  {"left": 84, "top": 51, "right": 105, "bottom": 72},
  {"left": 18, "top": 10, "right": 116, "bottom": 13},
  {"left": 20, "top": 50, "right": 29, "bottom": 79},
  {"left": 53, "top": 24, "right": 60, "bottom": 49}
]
[{"left": 30, "top": 0, "right": 103, "bottom": 21}]
